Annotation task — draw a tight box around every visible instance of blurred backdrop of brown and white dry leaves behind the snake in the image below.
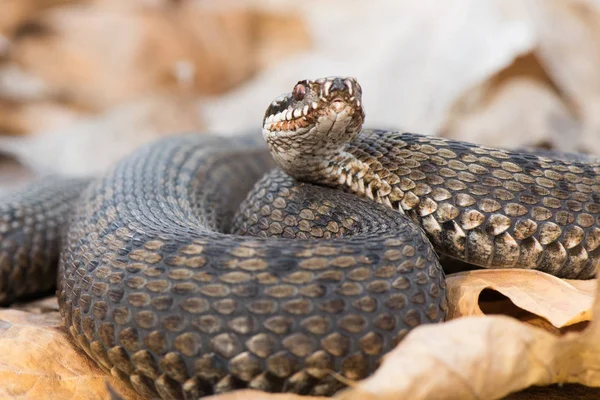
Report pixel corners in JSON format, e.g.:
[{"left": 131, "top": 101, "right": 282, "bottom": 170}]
[{"left": 0, "top": 0, "right": 600, "bottom": 193}]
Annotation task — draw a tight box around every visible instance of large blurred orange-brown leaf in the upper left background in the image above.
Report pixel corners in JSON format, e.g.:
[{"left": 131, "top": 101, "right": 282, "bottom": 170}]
[{"left": 0, "top": 1, "right": 310, "bottom": 111}]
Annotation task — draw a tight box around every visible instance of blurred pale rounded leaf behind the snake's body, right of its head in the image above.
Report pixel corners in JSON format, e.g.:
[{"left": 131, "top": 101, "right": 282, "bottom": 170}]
[{"left": 441, "top": 77, "right": 580, "bottom": 151}]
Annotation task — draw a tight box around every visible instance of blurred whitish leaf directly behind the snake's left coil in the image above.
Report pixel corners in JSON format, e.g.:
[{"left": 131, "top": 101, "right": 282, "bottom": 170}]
[{"left": 0, "top": 96, "right": 203, "bottom": 176}]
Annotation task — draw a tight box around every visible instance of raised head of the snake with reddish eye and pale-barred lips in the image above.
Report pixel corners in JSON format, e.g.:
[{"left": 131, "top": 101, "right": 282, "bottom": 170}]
[{"left": 262, "top": 76, "right": 365, "bottom": 179}]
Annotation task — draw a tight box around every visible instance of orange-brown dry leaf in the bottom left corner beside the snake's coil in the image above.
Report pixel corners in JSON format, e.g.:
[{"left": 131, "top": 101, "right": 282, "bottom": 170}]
[{"left": 0, "top": 309, "right": 140, "bottom": 400}]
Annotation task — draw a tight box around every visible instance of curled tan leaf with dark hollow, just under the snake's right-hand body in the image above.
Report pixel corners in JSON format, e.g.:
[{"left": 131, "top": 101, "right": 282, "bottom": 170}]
[{"left": 447, "top": 269, "right": 596, "bottom": 331}]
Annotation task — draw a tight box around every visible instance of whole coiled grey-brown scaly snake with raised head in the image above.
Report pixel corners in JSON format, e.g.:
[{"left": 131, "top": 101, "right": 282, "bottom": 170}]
[{"left": 0, "top": 76, "right": 600, "bottom": 399}]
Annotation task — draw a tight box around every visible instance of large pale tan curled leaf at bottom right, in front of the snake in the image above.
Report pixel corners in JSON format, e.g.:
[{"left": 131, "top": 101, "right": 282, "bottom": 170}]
[{"left": 341, "top": 316, "right": 564, "bottom": 400}]
